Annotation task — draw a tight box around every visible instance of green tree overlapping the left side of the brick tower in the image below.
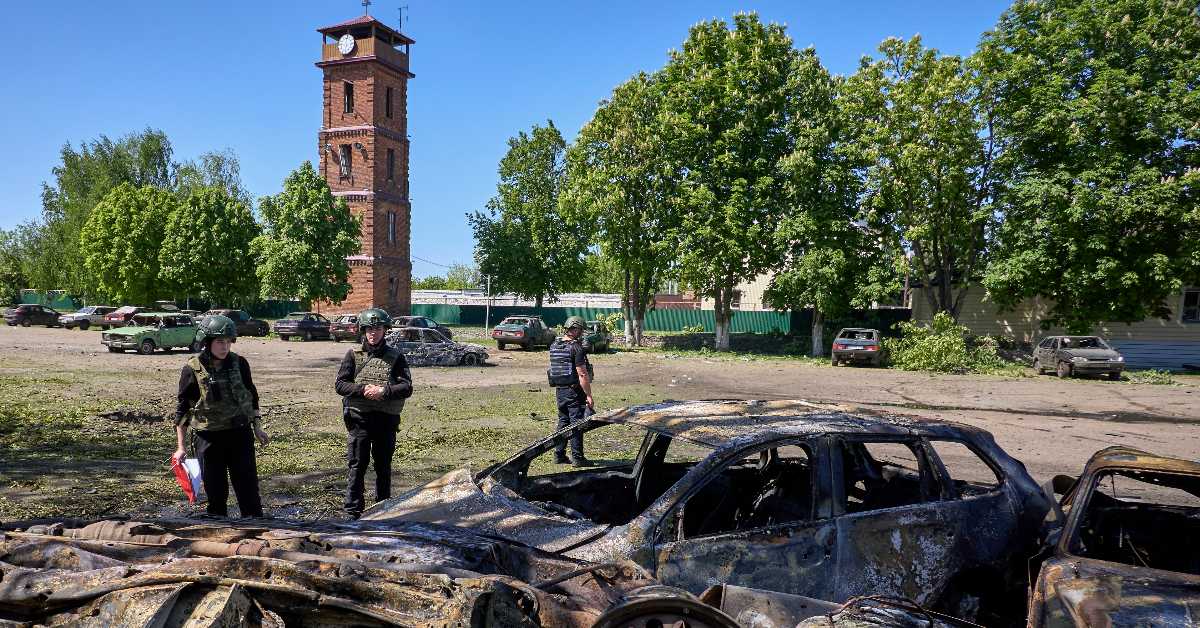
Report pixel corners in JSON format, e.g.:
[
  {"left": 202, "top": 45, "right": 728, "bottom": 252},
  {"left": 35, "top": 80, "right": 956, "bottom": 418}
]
[{"left": 251, "top": 161, "right": 362, "bottom": 304}]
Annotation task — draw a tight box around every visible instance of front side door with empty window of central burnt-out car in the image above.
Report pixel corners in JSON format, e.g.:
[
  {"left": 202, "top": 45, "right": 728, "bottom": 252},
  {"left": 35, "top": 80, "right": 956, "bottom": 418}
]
[{"left": 644, "top": 436, "right": 838, "bottom": 598}]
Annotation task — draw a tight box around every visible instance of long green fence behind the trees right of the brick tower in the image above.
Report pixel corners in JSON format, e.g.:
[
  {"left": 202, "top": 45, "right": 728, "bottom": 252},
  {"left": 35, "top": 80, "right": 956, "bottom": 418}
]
[{"left": 412, "top": 304, "right": 854, "bottom": 334}]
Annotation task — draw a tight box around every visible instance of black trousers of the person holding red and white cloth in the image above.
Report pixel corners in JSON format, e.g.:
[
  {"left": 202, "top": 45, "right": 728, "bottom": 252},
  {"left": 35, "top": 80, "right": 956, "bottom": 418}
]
[{"left": 194, "top": 426, "right": 263, "bottom": 516}]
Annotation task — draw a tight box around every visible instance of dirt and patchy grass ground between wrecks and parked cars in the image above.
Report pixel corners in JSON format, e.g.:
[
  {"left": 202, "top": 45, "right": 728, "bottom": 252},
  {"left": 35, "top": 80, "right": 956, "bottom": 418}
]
[{"left": 0, "top": 327, "right": 1200, "bottom": 520}]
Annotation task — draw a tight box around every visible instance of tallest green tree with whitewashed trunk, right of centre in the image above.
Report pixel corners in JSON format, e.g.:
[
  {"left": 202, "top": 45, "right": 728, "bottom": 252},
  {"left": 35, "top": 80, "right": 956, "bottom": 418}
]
[{"left": 662, "top": 13, "right": 804, "bottom": 349}]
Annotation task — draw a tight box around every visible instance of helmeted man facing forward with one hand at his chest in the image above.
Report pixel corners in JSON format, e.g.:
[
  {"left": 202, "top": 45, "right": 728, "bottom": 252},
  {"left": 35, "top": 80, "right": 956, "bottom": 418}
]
[{"left": 334, "top": 307, "right": 413, "bottom": 519}]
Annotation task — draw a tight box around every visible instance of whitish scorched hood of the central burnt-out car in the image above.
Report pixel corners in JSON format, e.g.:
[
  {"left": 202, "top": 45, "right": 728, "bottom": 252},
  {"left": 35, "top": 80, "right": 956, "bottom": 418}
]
[{"left": 362, "top": 468, "right": 608, "bottom": 552}]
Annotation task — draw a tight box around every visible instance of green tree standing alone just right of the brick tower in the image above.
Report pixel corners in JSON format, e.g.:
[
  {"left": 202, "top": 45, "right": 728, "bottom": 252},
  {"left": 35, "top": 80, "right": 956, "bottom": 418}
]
[{"left": 467, "top": 121, "right": 589, "bottom": 307}]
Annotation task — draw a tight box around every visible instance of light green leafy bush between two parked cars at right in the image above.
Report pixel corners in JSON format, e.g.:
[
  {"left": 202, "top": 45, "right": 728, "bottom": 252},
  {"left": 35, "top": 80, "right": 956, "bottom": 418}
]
[{"left": 883, "top": 312, "right": 1020, "bottom": 373}]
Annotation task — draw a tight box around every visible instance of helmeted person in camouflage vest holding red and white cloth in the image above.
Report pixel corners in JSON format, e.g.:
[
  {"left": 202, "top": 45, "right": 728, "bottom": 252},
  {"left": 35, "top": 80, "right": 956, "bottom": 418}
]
[{"left": 172, "top": 316, "right": 270, "bottom": 516}]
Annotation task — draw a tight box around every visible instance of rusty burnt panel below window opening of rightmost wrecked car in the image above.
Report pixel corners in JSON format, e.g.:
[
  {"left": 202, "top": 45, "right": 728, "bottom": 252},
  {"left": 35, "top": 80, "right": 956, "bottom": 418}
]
[{"left": 1034, "top": 558, "right": 1200, "bottom": 626}]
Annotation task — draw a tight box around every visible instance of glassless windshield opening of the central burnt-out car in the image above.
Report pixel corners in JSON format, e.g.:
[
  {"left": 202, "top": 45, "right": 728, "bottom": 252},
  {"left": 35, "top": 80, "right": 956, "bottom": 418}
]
[{"left": 487, "top": 420, "right": 713, "bottom": 526}]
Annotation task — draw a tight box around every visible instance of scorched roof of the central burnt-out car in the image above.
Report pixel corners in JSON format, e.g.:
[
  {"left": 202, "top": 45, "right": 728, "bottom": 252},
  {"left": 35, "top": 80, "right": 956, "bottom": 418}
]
[{"left": 595, "top": 400, "right": 982, "bottom": 448}]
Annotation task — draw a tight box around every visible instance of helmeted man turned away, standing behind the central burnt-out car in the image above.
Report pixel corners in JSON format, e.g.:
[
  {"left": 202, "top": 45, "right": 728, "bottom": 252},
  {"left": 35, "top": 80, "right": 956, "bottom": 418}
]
[{"left": 546, "top": 316, "right": 595, "bottom": 467}]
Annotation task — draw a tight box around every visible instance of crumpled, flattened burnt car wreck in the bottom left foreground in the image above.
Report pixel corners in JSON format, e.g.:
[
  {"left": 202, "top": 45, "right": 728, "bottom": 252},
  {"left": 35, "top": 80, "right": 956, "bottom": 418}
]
[{"left": 0, "top": 520, "right": 734, "bottom": 628}]
